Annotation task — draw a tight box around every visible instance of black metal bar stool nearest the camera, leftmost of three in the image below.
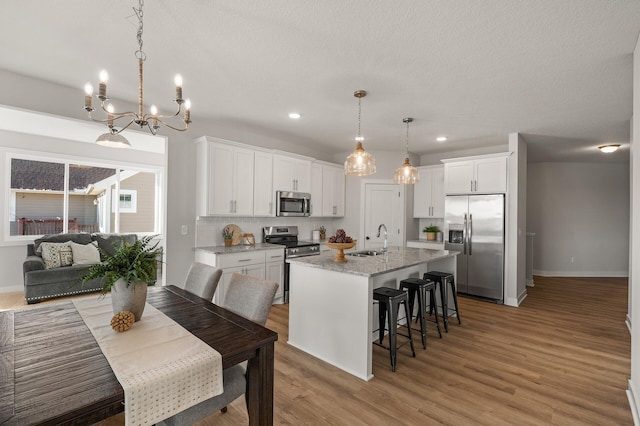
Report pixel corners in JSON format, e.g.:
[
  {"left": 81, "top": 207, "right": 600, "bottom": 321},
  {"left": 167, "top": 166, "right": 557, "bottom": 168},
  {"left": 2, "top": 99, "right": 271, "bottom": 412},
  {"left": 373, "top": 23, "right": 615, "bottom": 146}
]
[{"left": 373, "top": 287, "right": 416, "bottom": 371}]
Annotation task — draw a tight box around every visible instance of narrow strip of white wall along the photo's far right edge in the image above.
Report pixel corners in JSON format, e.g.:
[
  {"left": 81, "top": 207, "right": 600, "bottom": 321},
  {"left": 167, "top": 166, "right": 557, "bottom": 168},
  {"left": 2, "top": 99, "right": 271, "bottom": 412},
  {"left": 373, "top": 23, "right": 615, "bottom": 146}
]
[{"left": 627, "top": 30, "right": 640, "bottom": 425}]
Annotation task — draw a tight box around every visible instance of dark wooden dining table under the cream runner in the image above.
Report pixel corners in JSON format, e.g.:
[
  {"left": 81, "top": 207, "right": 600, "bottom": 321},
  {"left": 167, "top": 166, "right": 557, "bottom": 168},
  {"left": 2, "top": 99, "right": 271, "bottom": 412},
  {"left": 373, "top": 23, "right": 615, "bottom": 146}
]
[{"left": 0, "top": 285, "right": 278, "bottom": 425}]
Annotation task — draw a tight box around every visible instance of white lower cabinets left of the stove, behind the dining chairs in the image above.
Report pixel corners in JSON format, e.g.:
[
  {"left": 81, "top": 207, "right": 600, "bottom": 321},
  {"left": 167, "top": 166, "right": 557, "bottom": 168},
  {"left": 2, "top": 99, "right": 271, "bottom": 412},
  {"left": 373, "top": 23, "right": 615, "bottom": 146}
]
[{"left": 195, "top": 248, "right": 284, "bottom": 305}]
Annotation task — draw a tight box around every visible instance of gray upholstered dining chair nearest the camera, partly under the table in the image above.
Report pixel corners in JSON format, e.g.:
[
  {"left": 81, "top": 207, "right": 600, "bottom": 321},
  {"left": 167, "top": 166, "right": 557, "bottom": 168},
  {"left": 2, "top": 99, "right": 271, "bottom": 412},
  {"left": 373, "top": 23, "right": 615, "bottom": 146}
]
[{"left": 164, "top": 273, "right": 278, "bottom": 426}]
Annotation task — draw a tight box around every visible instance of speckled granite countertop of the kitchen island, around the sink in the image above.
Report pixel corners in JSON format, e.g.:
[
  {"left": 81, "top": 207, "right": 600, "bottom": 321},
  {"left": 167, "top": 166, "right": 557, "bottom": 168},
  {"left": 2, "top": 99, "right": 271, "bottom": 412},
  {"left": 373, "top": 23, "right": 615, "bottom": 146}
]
[{"left": 288, "top": 247, "right": 458, "bottom": 277}]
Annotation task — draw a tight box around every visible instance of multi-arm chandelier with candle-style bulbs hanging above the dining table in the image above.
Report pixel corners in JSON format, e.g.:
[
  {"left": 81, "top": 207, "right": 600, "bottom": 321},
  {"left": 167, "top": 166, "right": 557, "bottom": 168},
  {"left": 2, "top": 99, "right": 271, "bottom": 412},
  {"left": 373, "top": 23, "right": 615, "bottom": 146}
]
[{"left": 84, "top": 0, "right": 191, "bottom": 148}]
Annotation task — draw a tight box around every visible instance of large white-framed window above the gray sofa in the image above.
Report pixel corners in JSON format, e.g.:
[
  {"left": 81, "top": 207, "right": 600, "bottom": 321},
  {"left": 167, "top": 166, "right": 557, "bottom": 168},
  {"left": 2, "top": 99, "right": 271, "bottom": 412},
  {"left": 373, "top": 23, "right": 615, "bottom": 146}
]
[{"left": 5, "top": 154, "right": 161, "bottom": 238}]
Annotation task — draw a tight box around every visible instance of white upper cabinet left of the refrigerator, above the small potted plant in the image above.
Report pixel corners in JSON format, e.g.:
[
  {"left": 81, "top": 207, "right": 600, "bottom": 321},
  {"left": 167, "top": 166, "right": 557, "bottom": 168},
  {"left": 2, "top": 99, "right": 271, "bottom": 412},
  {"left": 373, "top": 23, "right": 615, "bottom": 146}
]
[{"left": 413, "top": 166, "right": 444, "bottom": 218}]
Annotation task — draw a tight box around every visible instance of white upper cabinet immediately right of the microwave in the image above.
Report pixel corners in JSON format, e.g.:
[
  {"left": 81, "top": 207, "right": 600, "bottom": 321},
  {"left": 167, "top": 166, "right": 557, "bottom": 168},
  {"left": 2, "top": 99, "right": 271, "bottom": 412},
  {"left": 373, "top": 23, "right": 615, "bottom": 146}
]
[{"left": 311, "top": 162, "right": 345, "bottom": 217}]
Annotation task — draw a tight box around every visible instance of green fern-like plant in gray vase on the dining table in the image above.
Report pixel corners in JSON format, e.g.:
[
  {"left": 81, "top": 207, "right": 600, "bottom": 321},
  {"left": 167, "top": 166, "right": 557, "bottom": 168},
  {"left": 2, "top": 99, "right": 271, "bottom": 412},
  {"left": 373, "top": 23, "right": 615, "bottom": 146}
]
[{"left": 81, "top": 235, "right": 162, "bottom": 321}]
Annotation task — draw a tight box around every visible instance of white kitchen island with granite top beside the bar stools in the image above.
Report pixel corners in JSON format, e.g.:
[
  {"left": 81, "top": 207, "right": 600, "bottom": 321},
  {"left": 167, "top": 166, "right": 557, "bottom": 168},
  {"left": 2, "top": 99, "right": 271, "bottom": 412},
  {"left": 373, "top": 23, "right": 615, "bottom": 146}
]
[{"left": 288, "top": 247, "right": 458, "bottom": 380}]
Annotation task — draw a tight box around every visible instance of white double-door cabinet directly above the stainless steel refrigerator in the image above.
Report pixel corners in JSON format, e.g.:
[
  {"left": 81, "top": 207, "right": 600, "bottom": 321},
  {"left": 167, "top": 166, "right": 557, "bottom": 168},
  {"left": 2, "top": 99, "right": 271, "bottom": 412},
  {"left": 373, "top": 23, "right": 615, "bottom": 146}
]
[{"left": 443, "top": 154, "right": 508, "bottom": 194}]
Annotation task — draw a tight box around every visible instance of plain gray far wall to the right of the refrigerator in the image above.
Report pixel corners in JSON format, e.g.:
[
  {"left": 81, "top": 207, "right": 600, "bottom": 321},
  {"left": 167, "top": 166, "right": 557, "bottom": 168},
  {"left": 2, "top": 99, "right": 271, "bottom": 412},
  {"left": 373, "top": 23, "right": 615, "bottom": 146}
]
[{"left": 527, "top": 163, "right": 629, "bottom": 276}]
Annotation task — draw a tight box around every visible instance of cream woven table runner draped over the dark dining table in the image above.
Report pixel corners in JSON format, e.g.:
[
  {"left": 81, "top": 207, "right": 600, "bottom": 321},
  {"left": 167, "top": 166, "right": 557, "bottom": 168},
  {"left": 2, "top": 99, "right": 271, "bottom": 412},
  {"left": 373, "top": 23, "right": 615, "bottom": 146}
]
[{"left": 73, "top": 295, "right": 223, "bottom": 425}]
